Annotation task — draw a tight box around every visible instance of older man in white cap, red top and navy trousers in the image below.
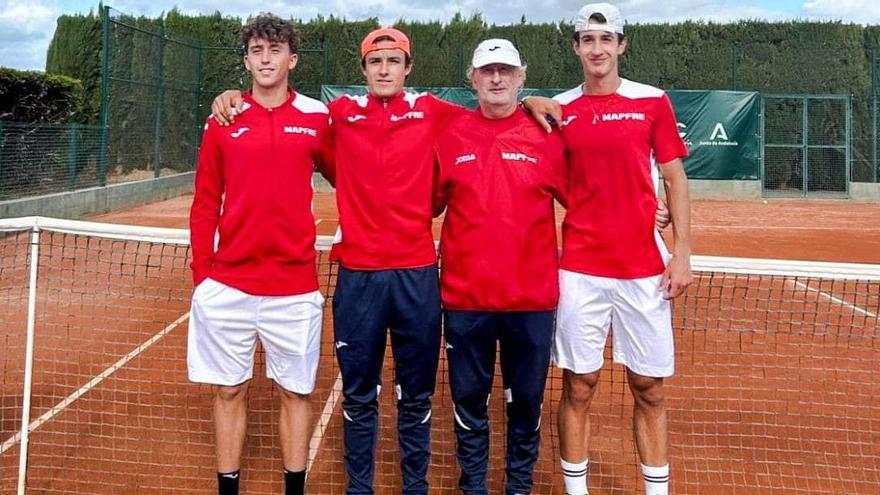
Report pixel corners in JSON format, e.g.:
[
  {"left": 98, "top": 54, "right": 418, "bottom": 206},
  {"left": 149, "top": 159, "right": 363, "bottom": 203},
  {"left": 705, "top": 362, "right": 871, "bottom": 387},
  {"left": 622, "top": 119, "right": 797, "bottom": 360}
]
[{"left": 435, "top": 39, "right": 565, "bottom": 495}]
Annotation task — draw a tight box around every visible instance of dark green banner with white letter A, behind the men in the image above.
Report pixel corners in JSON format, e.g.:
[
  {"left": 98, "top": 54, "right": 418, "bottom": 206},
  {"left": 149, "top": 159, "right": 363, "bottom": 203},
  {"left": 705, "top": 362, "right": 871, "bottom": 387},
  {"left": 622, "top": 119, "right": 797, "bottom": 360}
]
[{"left": 321, "top": 86, "right": 761, "bottom": 180}]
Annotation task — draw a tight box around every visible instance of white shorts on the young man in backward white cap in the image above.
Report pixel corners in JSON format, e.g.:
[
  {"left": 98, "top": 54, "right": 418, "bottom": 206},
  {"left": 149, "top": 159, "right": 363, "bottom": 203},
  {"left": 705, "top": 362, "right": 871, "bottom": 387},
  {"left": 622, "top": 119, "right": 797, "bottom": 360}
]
[{"left": 553, "top": 270, "right": 675, "bottom": 377}]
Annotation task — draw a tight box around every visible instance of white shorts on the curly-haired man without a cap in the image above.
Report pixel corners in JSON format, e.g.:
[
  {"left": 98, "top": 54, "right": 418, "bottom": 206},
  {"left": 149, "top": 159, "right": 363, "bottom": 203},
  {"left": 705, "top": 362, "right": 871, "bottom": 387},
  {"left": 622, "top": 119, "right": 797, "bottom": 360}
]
[{"left": 186, "top": 278, "right": 324, "bottom": 394}]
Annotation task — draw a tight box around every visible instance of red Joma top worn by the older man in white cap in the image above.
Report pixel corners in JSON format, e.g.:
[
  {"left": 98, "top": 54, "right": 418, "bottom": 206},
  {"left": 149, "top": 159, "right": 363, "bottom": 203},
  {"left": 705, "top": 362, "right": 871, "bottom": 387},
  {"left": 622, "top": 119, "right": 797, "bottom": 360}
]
[{"left": 435, "top": 110, "right": 567, "bottom": 311}]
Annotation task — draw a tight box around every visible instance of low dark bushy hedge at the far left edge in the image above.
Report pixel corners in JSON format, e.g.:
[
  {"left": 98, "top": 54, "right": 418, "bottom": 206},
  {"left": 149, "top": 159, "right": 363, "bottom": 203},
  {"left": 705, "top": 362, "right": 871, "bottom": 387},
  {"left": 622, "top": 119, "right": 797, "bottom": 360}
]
[{"left": 0, "top": 67, "right": 82, "bottom": 123}]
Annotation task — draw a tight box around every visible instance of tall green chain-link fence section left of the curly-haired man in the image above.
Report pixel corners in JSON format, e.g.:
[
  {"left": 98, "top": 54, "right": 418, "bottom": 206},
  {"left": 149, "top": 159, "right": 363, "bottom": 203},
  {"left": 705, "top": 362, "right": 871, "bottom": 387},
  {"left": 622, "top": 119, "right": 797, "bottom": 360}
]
[{"left": 102, "top": 7, "right": 201, "bottom": 184}]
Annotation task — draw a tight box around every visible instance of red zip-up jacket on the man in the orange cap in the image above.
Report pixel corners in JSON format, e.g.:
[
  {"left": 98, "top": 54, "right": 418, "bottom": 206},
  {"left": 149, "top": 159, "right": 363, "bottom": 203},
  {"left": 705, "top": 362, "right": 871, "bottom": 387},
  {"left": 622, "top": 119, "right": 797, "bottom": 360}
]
[{"left": 322, "top": 92, "right": 464, "bottom": 270}]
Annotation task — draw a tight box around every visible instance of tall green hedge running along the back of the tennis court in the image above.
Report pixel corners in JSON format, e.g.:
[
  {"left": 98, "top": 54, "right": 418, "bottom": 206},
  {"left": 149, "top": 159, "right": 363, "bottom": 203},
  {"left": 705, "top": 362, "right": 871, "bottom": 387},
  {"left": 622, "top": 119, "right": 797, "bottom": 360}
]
[{"left": 47, "top": 10, "right": 880, "bottom": 180}]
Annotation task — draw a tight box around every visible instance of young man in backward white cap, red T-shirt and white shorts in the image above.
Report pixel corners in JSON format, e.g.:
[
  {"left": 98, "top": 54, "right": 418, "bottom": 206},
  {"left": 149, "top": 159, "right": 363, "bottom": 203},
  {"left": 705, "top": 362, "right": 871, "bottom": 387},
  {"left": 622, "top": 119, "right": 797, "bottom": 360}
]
[{"left": 553, "top": 3, "right": 692, "bottom": 495}]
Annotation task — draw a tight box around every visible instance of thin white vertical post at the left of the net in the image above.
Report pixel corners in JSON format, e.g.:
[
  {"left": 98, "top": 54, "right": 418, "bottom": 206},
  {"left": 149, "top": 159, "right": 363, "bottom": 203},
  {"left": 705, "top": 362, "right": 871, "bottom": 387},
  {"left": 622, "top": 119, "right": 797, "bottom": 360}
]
[{"left": 17, "top": 225, "right": 40, "bottom": 495}]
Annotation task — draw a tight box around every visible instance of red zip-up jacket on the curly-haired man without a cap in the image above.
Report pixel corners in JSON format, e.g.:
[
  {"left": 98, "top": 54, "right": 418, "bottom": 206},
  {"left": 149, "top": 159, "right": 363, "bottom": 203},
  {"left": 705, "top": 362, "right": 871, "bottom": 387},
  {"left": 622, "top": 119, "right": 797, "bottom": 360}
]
[{"left": 190, "top": 90, "right": 328, "bottom": 296}]
